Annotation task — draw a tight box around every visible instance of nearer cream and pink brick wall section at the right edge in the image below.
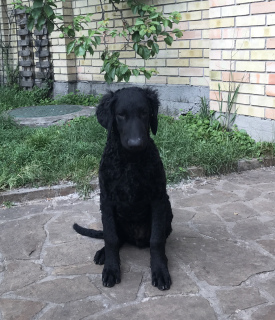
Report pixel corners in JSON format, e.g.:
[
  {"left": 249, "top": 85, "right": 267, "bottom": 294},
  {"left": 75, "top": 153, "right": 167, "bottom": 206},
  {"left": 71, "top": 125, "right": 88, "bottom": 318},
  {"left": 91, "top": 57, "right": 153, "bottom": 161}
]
[{"left": 209, "top": 0, "right": 275, "bottom": 119}]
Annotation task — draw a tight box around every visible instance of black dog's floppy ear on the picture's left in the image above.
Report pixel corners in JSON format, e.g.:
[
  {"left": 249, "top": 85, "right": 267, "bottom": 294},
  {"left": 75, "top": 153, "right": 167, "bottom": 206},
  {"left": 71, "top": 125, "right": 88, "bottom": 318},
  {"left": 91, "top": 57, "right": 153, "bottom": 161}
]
[{"left": 96, "top": 91, "right": 115, "bottom": 131}]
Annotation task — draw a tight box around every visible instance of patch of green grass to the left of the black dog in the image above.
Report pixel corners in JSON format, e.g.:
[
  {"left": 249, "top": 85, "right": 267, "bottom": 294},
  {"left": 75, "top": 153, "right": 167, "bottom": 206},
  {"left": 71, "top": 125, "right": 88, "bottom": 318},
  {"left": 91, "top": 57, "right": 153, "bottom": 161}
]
[{"left": 0, "top": 116, "right": 106, "bottom": 194}]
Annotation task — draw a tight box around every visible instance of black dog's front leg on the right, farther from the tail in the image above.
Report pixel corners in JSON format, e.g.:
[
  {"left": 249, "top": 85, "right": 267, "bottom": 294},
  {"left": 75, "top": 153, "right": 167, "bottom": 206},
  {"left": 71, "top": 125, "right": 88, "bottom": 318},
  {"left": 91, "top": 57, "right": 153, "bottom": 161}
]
[{"left": 150, "top": 201, "right": 172, "bottom": 290}]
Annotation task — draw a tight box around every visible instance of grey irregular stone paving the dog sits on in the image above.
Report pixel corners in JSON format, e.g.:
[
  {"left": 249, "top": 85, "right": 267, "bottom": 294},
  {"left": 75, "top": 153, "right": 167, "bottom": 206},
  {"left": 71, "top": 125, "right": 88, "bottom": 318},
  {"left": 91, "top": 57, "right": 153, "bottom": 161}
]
[{"left": 0, "top": 167, "right": 275, "bottom": 320}]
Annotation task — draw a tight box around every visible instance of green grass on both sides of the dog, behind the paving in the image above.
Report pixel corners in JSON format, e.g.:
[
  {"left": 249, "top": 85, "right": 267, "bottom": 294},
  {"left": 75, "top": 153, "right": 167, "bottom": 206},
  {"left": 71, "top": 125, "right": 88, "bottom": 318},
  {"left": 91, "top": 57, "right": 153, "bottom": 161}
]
[{"left": 0, "top": 89, "right": 274, "bottom": 192}]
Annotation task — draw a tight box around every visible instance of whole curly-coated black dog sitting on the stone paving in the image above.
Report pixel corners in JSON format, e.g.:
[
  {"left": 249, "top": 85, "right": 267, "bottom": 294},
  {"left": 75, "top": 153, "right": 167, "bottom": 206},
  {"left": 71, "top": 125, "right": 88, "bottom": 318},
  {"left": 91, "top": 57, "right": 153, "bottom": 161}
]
[{"left": 74, "top": 87, "right": 173, "bottom": 290}]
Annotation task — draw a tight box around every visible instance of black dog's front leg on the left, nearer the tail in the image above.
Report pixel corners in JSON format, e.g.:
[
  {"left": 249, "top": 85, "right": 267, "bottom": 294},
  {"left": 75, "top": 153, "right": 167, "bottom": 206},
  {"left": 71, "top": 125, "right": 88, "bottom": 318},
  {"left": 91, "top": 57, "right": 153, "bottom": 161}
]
[{"left": 101, "top": 204, "right": 120, "bottom": 287}]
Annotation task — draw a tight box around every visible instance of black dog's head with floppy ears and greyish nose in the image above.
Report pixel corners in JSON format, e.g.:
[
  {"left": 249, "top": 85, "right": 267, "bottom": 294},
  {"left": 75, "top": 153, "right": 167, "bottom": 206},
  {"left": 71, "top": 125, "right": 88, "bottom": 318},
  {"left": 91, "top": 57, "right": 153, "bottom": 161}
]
[{"left": 96, "top": 87, "right": 159, "bottom": 151}]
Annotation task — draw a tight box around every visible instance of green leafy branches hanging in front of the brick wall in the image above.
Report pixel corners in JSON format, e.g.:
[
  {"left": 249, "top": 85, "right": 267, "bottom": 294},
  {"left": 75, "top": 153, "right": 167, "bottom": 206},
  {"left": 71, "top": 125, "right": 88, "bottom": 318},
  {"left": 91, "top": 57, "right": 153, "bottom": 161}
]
[{"left": 15, "top": 0, "right": 182, "bottom": 83}]
